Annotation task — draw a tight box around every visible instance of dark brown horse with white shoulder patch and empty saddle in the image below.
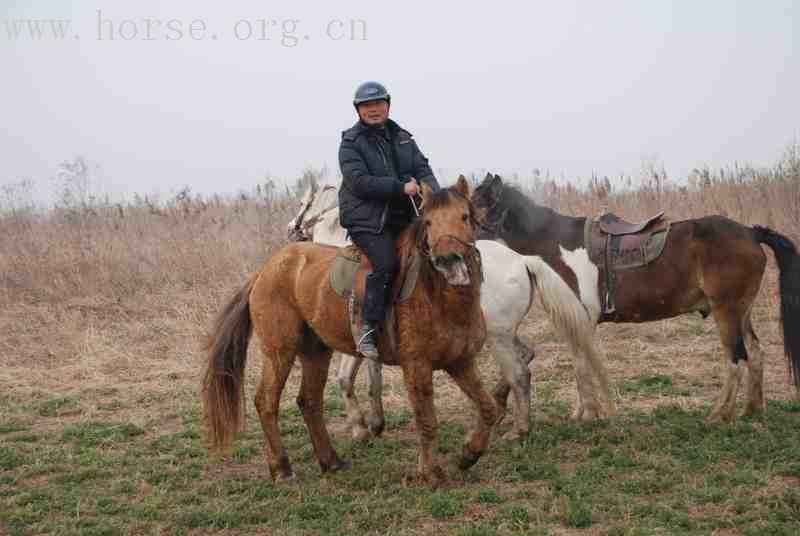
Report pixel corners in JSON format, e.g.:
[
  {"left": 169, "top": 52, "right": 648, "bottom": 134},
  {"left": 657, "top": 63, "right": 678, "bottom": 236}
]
[{"left": 472, "top": 174, "right": 800, "bottom": 420}]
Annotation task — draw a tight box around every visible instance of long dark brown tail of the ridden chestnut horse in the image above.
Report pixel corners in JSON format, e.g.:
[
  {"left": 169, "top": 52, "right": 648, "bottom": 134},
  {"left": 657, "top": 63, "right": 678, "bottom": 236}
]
[{"left": 203, "top": 277, "right": 256, "bottom": 449}]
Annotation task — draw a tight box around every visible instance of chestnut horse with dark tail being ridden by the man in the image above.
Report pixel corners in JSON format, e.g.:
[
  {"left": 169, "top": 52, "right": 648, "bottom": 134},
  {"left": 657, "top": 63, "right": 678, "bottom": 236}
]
[{"left": 203, "top": 180, "right": 497, "bottom": 486}]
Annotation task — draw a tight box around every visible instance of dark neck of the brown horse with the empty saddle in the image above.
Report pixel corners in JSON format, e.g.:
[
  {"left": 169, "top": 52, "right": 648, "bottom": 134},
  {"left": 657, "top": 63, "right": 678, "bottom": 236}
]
[{"left": 500, "top": 202, "right": 586, "bottom": 260}]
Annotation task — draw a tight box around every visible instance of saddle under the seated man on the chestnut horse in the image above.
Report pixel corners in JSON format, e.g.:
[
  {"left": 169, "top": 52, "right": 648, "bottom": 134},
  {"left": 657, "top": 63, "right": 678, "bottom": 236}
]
[{"left": 331, "top": 229, "right": 422, "bottom": 355}]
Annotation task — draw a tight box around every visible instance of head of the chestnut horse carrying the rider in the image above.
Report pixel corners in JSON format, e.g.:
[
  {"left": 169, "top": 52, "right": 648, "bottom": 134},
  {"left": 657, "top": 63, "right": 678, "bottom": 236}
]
[{"left": 419, "top": 175, "right": 478, "bottom": 286}]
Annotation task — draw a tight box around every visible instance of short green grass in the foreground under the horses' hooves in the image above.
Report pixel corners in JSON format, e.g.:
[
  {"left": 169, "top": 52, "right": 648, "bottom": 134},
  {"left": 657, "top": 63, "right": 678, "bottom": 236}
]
[{"left": 0, "top": 386, "right": 800, "bottom": 536}]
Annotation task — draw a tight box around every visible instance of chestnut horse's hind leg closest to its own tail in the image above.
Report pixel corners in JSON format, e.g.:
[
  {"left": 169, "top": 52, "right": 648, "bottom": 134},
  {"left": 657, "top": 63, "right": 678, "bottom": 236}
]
[{"left": 255, "top": 344, "right": 295, "bottom": 480}]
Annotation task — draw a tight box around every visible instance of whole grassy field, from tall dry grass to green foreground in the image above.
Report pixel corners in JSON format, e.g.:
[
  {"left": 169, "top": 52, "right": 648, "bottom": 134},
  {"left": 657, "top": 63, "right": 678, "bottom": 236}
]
[{"left": 0, "top": 160, "right": 800, "bottom": 536}]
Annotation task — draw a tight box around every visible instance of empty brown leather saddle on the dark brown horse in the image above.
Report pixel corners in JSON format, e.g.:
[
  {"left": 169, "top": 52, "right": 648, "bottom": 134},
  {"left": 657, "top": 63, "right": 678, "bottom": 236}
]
[{"left": 584, "top": 211, "right": 670, "bottom": 316}]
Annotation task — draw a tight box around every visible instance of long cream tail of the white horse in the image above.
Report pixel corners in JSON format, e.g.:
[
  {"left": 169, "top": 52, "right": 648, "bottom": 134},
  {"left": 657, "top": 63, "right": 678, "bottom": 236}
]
[{"left": 523, "top": 256, "right": 616, "bottom": 416}]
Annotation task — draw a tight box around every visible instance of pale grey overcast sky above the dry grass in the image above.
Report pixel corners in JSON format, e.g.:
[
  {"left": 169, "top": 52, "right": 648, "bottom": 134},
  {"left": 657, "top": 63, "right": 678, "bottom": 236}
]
[{"left": 0, "top": 0, "right": 800, "bottom": 201}]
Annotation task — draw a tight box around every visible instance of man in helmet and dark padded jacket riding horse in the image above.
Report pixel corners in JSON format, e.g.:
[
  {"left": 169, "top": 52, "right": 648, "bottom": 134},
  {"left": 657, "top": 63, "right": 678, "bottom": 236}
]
[{"left": 339, "top": 82, "right": 439, "bottom": 359}]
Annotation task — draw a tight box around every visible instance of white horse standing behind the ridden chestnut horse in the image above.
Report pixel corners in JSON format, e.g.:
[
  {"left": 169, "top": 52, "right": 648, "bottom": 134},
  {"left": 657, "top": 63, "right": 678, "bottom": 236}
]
[{"left": 288, "top": 180, "right": 613, "bottom": 441}]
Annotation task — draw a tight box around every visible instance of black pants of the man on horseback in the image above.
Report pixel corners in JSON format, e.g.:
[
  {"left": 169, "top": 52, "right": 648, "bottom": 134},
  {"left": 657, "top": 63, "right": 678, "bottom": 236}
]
[{"left": 350, "top": 229, "right": 400, "bottom": 328}]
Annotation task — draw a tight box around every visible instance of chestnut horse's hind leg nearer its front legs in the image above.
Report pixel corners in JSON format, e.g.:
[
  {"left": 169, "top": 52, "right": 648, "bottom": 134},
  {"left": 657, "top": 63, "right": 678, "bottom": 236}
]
[{"left": 297, "top": 350, "right": 345, "bottom": 473}]
